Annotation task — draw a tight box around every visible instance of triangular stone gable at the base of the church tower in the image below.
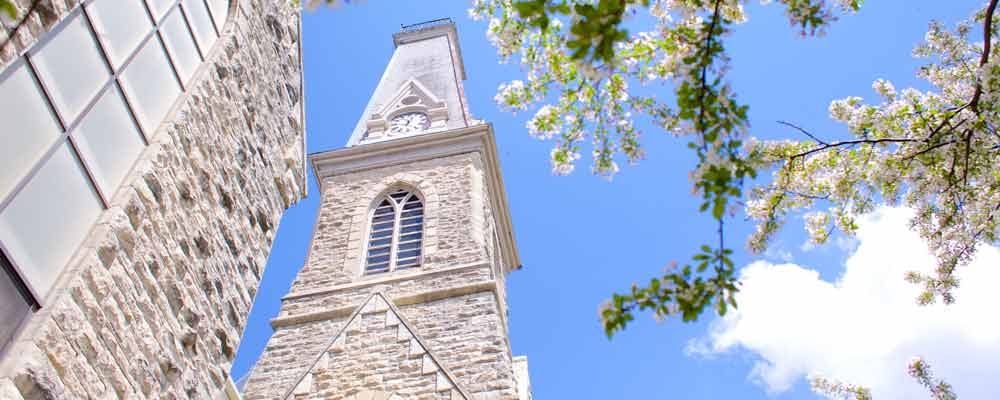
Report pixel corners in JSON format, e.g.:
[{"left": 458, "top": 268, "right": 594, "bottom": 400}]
[{"left": 282, "top": 292, "right": 472, "bottom": 400}]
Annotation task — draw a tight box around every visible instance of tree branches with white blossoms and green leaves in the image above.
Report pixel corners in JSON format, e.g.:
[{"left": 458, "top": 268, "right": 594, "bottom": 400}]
[{"left": 470, "top": 0, "right": 1000, "bottom": 399}]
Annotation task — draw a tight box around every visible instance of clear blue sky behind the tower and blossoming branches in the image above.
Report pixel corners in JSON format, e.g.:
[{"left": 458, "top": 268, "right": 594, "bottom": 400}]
[{"left": 233, "top": 0, "right": 992, "bottom": 399}]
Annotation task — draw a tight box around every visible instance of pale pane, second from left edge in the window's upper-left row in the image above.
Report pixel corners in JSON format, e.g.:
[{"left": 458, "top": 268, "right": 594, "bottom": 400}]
[{"left": 31, "top": 12, "right": 110, "bottom": 123}]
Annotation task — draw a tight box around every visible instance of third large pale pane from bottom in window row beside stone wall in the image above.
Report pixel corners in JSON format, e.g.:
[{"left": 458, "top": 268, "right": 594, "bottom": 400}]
[{"left": 121, "top": 40, "right": 181, "bottom": 134}]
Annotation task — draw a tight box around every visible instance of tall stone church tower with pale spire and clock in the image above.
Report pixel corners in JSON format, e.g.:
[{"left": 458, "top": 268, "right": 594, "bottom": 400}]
[{"left": 244, "top": 19, "right": 531, "bottom": 400}]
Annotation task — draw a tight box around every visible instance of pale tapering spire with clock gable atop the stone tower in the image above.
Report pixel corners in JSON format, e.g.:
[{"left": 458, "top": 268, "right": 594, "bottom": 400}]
[{"left": 347, "top": 18, "right": 472, "bottom": 147}]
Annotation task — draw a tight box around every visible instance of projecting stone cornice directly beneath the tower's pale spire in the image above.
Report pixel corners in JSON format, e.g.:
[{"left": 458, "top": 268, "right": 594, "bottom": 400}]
[{"left": 309, "top": 123, "right": 521, "bottom": 272}]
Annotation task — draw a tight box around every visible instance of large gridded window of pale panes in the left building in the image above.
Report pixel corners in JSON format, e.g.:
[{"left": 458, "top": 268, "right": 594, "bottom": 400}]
[{"left": 0, "top": 0, "right": 229, "bottom": 349}]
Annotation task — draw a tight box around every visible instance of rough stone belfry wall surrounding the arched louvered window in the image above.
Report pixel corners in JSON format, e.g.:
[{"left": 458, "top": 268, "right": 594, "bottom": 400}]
[{"left": 289, "top": 153, "right": 486, "bottom": 295}]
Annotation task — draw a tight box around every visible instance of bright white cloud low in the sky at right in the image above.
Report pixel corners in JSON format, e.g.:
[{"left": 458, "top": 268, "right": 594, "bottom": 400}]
[{"left": 689, "top": 208, "right": 1000, "bottom": 400}]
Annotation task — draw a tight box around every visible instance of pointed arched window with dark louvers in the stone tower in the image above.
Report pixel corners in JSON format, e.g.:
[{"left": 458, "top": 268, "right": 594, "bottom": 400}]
[{"left": 365, "top": 189, "right": 424, "bottom": 274}]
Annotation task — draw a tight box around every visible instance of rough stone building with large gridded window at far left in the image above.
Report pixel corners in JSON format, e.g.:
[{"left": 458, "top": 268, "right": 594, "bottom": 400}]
[{"left": 0, "top": 0, "right": 306, "bottom": 400}]
